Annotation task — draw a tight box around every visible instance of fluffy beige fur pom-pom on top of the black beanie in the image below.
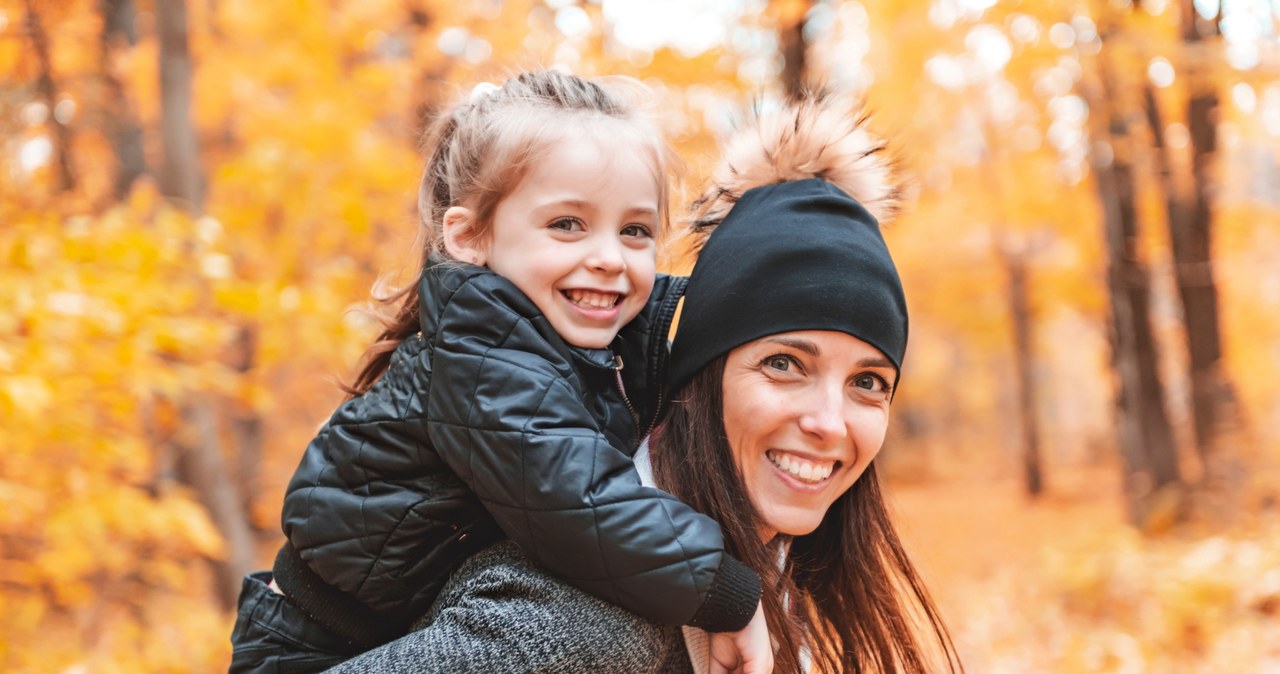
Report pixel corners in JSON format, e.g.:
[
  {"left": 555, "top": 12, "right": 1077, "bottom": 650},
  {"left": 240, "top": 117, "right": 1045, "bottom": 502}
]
[{"left": 689, "top": 92, "right": 902, "bottom": 251}]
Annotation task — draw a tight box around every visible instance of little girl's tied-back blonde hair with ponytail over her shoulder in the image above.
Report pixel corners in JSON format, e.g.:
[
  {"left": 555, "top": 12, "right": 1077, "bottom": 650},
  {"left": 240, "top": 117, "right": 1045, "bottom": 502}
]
[{"left": 343, "top": 70, "right": 672, "bottom": 396}]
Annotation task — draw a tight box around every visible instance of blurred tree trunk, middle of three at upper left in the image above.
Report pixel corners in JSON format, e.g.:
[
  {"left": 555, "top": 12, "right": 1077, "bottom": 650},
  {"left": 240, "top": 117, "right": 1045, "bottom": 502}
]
[{"left": 99, "top": 0, "right": 146, "bottom": 202}]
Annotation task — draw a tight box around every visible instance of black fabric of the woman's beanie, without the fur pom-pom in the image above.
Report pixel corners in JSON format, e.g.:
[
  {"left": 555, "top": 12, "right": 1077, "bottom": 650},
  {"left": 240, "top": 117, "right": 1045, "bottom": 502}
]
[{"left": 668, "top": 179, "right": 906, "bottom": 391}]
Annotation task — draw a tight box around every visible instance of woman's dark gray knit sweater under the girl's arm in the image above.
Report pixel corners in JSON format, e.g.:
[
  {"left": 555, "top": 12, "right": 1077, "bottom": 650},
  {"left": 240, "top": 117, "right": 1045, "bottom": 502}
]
[{"left": 329, "top": 541, "right": 692, "bottom": 674}]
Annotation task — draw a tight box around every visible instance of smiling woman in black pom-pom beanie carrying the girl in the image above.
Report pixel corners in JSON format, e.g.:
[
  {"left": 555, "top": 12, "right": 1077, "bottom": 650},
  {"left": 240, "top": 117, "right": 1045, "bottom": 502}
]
[{"left": 320, "top": 98, "right": 961, "bottom": 673}]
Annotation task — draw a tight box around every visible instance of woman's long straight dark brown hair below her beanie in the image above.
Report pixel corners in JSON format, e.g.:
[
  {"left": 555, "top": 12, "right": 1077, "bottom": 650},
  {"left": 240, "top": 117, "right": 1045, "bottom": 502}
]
[{"left": 650, "top": 356, "right": 964, "bottom": 674}]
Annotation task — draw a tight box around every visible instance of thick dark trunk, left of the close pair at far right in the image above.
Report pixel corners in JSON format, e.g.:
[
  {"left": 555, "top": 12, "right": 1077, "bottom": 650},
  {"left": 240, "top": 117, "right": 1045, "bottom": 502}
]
[{"left": 1084, "top": 49, "right": 1181, "bottom": 528}]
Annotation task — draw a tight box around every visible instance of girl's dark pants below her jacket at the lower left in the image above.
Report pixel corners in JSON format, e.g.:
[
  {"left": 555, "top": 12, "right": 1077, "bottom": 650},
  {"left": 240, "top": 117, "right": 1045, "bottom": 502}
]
[{"left": 230, "top": 572, "right": 360, "bottom": 674}]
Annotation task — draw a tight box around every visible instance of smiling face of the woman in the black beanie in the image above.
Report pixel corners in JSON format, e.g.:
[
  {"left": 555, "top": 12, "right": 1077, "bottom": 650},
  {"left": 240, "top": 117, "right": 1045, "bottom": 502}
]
[{"left": 723, "top": 330, "right": 897, "bottom": 540}]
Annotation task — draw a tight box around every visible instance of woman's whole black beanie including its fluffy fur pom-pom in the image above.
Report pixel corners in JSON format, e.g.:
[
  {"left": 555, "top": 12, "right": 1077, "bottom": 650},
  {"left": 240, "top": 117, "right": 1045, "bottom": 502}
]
[{"left": 668, "top": 91, "right": 908, "bottom": 394}]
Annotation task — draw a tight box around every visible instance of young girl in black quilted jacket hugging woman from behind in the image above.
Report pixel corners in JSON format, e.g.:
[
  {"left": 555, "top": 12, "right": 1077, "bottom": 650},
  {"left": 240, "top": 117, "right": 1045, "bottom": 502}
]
[{"left": 232, "top": 72, "right": 772, "bottom": 671}]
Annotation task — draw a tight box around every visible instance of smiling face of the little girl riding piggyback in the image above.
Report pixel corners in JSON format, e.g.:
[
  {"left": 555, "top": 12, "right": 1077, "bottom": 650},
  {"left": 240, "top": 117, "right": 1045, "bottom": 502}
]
[{"left": 476, "top": 134, "right": 660, "bottom": 349}]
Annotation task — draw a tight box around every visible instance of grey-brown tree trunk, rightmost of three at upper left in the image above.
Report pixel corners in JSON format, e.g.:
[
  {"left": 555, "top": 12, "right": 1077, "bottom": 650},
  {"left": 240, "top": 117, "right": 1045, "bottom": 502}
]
[{"left": 155, "top": 0, "right": 204, "bottom": 214}]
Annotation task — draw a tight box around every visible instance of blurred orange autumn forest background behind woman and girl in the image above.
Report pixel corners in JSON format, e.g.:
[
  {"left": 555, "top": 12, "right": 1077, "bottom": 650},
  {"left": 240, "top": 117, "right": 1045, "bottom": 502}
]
[{"left": 0, "top": 0, "right": 1280, "bottom": 673}]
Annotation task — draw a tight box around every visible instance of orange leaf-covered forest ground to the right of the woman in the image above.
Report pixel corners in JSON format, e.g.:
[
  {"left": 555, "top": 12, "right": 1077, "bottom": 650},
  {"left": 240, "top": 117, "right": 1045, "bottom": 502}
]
[{"left": 893, "top": 464, "right": 1280, "bottom": 674}]
